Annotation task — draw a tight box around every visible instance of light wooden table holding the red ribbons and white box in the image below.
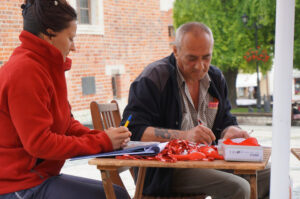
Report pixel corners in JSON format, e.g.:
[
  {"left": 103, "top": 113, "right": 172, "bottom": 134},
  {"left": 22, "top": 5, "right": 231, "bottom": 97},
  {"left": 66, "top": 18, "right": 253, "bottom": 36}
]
[{"left": 89, "top": 148, "right": 271, "bottom": 199}]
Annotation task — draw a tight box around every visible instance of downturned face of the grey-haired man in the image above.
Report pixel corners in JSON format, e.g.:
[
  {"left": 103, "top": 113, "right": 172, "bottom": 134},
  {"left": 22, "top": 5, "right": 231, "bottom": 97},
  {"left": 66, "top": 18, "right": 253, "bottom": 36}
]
[{"left": 173, "top": 31, "right": 213, "bottom": 81}]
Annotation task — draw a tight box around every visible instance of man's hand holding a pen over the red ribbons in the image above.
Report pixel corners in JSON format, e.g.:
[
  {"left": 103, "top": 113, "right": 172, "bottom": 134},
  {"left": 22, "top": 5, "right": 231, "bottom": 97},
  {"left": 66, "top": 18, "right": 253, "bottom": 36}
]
[{"left": 186, "top": 125, "right": 216, "bottom": 144}]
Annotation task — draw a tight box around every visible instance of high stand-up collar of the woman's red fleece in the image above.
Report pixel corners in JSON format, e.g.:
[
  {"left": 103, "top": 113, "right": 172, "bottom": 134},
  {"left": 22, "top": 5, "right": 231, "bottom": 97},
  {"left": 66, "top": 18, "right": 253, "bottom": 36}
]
[{"left": 19, "top": 30, "right": 72, "bottom": 71}]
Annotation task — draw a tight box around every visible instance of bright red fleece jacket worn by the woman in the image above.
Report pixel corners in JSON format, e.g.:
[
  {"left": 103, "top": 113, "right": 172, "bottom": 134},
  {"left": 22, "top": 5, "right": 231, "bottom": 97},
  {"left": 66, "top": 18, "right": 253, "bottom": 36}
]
[{"left": 0, "top": 31, "right": 113, "bottom": 194}]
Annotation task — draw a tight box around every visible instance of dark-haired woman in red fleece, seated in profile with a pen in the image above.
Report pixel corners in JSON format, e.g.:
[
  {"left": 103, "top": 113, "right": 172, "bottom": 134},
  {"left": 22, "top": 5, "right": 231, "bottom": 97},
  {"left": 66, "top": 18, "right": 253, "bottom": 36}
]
[{"left": 0, "top": 0, "right": 131, "bottom": 199}]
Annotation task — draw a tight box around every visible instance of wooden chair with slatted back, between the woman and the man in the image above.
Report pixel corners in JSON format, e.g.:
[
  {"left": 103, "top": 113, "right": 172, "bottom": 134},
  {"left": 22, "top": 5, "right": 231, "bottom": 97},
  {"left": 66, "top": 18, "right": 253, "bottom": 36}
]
[{"left": 90, "top": 100, "right": 205, "bottom": 199}]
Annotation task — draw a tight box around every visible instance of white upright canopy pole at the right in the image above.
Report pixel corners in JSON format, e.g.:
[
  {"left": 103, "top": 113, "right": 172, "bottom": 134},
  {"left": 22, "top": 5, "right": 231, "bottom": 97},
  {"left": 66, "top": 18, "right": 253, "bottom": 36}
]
[{"left": 270, "top": 0, "right": 295, "bottom": 199}]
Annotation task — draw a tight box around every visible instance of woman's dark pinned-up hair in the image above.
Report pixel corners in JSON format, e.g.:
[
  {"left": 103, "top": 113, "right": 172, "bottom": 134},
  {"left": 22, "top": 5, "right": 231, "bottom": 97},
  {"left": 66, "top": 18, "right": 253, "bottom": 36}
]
[{"left": 21, "top": 0, "right": 77, "bottom": 37}]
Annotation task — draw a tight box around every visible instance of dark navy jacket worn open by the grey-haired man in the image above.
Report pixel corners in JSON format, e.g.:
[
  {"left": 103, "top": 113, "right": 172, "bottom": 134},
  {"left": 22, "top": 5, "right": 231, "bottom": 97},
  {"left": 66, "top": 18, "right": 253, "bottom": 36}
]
[{"left": 122, "top": 54, "right": 237, "bottom": 196}]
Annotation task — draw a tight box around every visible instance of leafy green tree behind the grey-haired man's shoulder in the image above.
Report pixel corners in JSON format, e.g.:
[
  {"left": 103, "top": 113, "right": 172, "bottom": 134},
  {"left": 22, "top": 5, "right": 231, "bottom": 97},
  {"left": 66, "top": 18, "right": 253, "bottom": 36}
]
[{"left": 173, "top": 0, "right": 275, "bottom": 107}]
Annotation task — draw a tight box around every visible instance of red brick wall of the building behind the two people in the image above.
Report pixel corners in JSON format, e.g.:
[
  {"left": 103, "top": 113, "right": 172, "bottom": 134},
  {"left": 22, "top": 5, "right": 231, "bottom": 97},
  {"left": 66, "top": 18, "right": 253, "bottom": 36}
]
[{"left": 0, "top": 0, "right": 171, "bottom": 123}]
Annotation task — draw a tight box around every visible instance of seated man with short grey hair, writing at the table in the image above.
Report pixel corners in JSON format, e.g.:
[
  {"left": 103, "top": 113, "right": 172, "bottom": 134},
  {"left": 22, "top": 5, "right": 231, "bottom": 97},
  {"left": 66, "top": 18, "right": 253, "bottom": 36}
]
[{"left": 122, "top": 22, "right": 270, "bottom": 199}]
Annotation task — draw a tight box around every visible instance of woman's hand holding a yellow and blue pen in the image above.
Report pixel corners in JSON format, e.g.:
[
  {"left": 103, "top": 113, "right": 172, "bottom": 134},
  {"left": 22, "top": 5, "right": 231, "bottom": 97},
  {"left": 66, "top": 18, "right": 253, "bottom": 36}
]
[{"left": 105, "top": 126, "right": 131, "bottom": 150}]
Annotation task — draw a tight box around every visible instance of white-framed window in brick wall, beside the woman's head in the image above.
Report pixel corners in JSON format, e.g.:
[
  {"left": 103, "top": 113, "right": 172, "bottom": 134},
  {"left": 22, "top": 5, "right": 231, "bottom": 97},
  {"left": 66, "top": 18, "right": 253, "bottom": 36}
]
[{"left": 68, "top": 0, "right": 104, "bottom": 35}]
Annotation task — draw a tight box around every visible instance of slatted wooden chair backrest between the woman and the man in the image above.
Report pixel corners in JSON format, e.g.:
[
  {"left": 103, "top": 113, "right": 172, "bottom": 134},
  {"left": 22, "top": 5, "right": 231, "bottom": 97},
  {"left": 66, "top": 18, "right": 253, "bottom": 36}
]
[{"left": 90, "top": 100, "right": 121, "bottom": 131}]
